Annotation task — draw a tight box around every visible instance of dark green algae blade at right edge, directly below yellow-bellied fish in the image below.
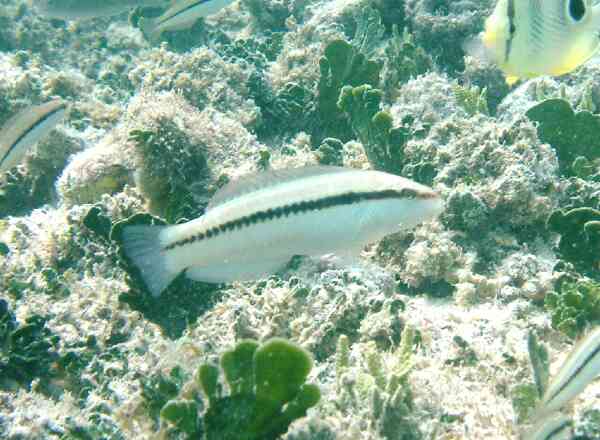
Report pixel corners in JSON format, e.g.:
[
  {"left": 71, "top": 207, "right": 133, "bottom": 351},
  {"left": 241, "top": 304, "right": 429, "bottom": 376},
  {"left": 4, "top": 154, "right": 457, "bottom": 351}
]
[{"left": 525, "top": 99, "right": 600, "bottom": 177}]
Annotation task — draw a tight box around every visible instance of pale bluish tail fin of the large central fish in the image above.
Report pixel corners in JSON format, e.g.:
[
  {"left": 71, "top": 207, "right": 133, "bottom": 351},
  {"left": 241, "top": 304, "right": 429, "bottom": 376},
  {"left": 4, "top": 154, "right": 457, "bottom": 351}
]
[{"left": 121, "top": 225, "right": 179, "bottom": 297}]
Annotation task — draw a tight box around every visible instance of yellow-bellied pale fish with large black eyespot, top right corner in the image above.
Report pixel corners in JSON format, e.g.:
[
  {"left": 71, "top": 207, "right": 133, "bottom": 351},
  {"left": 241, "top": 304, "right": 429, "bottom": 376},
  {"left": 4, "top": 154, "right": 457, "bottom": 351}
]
[{"left": 464, "top": 0, "right": 600, "bottom": 85}]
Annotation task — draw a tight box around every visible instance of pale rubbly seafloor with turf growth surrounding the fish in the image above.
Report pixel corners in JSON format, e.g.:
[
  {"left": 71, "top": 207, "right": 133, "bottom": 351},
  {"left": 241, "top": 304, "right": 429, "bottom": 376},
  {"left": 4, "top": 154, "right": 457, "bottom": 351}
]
[{"left": 0, "top": 0, "right": 600, "bottom": 440}]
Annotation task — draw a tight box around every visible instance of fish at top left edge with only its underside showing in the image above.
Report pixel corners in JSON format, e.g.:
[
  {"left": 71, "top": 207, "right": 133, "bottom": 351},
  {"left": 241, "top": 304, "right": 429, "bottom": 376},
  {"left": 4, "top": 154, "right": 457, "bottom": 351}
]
[{"left": 31, "top": 0, "right": 168, "bottom": 20}]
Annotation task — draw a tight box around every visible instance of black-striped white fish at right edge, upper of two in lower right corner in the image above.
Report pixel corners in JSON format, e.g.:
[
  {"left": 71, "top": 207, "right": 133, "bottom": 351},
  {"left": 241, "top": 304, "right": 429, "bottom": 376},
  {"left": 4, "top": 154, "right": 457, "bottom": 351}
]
[{"left": 534, "top": 327, "right": 600, "bottom": 419}]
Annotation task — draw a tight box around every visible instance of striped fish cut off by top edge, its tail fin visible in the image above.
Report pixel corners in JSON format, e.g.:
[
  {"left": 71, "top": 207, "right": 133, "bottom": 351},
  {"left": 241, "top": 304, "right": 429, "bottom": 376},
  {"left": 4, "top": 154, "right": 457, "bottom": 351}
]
[{"left": 139, "top": 0, "right": 235, "bottom": 43}]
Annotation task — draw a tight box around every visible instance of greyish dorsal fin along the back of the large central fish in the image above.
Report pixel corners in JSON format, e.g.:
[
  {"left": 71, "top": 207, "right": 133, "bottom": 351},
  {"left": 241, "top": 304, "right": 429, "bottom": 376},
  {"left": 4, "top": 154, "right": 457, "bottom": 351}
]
[{"left": 206, "top": 165, "right": 351, "bottom": 211}]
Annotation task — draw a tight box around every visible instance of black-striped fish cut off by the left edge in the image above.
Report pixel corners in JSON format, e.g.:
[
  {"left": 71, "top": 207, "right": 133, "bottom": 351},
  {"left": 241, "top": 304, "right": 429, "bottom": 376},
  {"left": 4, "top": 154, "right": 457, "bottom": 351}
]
[{"left": 0, "top": 99, "right": 67, "bottom": 173}]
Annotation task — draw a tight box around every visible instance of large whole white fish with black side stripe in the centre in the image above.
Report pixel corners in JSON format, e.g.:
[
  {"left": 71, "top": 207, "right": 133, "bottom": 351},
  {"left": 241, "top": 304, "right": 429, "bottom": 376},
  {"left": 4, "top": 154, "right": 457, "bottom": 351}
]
[{"left": 121, "top": 166, "right": 442, "bottom": 296}]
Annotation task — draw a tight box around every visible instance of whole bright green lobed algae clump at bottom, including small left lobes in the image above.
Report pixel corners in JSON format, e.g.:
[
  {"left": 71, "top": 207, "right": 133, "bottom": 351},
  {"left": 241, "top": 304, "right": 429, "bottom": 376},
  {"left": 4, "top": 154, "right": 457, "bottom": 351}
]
[{"left": 153, "top": 338, "right": 320, "bottom": 440}]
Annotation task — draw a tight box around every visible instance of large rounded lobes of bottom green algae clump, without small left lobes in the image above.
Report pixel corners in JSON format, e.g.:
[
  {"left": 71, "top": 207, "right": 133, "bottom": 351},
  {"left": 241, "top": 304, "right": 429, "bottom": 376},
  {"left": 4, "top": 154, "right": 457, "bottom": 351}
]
[{"left": 200, "top": 339, "right": 320, "bottom": 440}]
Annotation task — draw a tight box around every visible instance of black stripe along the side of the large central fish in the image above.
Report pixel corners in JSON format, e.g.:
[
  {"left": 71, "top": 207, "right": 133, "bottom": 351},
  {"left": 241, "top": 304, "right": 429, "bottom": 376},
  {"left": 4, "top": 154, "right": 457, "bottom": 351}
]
[{"left": 163, "top": 188, "right": 424, "bottom": 251}]
